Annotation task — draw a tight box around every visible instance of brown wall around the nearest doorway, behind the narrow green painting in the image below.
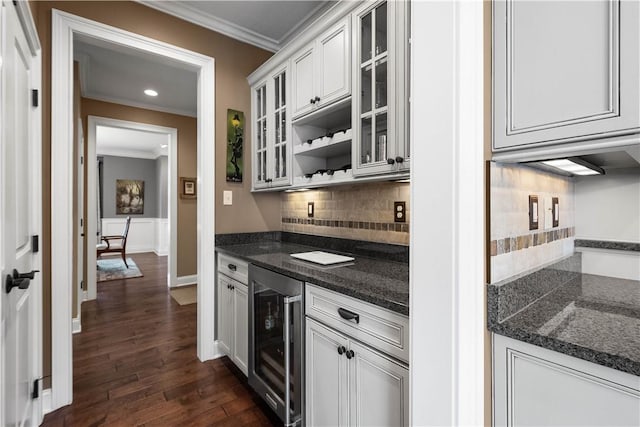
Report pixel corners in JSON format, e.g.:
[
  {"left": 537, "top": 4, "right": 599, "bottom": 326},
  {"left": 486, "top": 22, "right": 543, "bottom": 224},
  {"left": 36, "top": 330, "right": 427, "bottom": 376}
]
[{"left": 30, "top": 1, "right": 280, "bottom": 387}]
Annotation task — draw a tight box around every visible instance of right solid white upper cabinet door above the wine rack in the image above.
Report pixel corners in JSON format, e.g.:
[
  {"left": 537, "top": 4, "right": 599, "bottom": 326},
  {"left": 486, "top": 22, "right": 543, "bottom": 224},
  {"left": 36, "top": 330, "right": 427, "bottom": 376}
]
[{"left": 317, "top": 19, "right": 351, "bottom": 105}]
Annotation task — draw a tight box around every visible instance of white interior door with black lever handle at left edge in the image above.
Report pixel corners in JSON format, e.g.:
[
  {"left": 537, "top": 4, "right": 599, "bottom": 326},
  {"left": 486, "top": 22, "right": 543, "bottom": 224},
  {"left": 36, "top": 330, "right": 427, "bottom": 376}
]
[{"left": 0, "top": 1, "right": 41, "bottom": 426}]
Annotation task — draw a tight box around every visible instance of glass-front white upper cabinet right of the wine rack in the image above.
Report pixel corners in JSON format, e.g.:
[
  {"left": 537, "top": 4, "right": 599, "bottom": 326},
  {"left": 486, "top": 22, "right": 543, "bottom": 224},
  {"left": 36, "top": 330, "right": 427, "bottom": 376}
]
[{"left": 352, "top": 1, "right": 409, "bottom": 176}]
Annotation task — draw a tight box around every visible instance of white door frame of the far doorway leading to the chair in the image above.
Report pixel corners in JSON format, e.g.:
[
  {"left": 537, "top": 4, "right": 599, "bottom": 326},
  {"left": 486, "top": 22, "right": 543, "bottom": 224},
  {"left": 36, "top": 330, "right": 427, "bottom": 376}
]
[{"left": 85, "top": 116, "right": 178, "bottom": 300}]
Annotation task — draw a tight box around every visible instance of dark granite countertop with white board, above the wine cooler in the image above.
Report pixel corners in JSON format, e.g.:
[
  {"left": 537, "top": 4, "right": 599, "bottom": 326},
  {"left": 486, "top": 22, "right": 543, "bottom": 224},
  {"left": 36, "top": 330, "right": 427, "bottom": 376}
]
[{"left": 216, "top": 241, "right": 409, "bottom": 315}]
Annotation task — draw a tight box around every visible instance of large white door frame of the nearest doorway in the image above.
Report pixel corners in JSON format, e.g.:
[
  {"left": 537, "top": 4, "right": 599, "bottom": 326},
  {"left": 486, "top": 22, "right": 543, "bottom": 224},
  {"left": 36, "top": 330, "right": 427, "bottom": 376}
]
[{"left": 51, "top": 9, "right": 217, "bottom": 410}]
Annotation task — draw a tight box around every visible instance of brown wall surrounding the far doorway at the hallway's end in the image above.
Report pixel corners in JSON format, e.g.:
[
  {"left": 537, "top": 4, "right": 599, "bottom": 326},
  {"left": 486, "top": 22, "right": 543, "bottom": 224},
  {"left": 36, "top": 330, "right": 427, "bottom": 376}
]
[{"left": 82, "top": 98, "right": 198, "bottom": 277}]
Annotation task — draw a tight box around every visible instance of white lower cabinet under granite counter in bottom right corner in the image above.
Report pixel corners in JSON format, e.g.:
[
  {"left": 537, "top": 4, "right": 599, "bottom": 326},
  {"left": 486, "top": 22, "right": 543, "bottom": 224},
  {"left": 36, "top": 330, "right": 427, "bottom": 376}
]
[{"left": 493, "top": 334, "right": 640, "bottom": 426}]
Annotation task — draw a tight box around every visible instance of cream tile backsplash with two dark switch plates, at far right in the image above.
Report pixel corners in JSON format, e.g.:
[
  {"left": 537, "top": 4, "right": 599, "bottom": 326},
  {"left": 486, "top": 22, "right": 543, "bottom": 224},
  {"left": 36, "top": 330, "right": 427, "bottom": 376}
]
[{"left": 489, "top": 162, "right": 575, "bottom": 283}]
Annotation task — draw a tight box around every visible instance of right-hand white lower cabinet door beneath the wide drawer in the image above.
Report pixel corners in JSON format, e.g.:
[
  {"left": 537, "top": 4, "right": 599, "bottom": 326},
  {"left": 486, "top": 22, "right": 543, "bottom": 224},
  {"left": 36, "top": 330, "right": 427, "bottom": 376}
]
[{"left": 349, "top": 342, "right": 409, "bottom": 426}]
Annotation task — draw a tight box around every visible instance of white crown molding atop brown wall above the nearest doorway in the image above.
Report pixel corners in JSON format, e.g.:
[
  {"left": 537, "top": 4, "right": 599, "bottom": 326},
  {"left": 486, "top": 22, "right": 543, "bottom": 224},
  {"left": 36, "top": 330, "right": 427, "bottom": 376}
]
[{"left": 136, "top": 0, "right": 278, "bottom": 52}]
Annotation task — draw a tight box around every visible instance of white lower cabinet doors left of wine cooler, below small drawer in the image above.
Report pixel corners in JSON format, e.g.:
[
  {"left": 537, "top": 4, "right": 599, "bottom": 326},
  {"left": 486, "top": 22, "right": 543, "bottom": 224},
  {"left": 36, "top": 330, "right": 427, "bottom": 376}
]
[{"left": 218, "top": 274, "right": 249, "bottom": 375}]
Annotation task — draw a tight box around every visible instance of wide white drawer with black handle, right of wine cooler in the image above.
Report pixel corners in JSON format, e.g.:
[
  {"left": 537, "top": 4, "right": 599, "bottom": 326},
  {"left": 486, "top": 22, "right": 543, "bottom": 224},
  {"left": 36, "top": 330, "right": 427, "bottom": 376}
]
[{"left": 305, "top": 283, "right": 409, "bottom": 363}]
